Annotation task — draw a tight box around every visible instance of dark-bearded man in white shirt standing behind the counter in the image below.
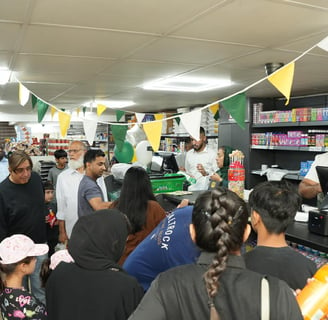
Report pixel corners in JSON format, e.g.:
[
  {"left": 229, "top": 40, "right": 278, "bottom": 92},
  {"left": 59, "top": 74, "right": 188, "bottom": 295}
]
[{"left": 185, "top": 127, "right": 218, "bottom": 191}]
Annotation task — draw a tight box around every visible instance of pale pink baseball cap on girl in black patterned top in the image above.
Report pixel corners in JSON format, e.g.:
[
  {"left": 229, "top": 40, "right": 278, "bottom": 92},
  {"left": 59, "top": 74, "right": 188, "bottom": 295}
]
[{"left": 0, "top": 234, "right": 49, "bottom": 264}]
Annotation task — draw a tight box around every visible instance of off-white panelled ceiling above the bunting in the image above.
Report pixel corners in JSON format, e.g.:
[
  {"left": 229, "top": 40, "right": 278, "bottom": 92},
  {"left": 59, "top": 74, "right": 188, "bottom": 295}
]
[{"left": 0, "top": 0, "right": 328, "bottom": 121}]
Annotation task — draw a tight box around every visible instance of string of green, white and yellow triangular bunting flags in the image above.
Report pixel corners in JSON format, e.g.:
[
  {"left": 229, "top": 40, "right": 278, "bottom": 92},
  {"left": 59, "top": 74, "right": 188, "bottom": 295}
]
[{"left": 17, "top": 36, "right": 328, "bottom": 136}]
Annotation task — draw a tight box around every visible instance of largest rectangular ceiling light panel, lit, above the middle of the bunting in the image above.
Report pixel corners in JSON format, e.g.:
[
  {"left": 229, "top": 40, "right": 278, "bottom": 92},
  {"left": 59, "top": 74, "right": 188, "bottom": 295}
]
[{"left": 142, "top": 76, "right": 232, "bottom": 92}]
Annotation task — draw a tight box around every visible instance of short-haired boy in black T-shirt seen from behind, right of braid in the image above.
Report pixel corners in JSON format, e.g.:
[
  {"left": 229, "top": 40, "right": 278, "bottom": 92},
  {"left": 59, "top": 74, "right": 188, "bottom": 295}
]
[{"left": 244, "top": 181, "right": 316, "bottom": 290}]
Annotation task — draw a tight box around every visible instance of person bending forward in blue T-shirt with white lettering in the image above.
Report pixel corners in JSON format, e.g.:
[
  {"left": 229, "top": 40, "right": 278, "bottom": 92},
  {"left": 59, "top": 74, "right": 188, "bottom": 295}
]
[{"left": 123, "top": 206, "right": 200, "bottom": 291}]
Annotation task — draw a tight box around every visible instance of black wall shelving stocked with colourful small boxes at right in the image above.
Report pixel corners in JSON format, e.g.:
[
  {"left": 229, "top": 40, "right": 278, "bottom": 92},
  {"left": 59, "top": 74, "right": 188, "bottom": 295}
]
[{"left": 246, "top": 95, "right": 328, "bottom": 187}]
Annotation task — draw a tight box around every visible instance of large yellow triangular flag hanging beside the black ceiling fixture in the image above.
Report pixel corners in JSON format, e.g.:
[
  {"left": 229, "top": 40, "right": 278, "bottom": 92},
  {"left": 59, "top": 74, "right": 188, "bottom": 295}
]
[{"left": 268, "top": 62, "right": 295, "bottom": 105}]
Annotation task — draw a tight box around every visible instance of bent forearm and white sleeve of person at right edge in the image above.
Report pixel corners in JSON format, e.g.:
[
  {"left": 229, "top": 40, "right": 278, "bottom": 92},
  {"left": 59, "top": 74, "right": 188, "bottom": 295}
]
[{"left": 298, "top": 152, "right": 328, "bottom": 199}]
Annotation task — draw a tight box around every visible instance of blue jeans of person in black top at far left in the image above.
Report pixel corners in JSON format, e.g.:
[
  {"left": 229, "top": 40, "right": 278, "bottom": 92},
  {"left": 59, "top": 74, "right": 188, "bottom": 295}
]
[{"left": 24, "top": 253, "right": 48, "bottom": 304}]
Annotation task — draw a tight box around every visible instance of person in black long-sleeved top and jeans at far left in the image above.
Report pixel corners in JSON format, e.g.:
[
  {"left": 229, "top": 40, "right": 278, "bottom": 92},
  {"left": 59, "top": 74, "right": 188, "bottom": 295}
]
[{"left": 0, "top": 151, "right": 47, "bottom": 303}]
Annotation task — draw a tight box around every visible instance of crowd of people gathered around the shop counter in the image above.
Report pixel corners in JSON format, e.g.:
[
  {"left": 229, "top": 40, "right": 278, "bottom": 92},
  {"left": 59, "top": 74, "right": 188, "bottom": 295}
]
[{"left": 0, "top": 141, "right": 316, "bottom": 320}]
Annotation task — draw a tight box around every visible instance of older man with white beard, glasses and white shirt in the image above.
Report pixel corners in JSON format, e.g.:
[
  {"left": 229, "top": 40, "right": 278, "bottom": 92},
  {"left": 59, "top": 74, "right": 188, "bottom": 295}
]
[{"left": 56, "top": 141, "right": 107, "bottom": 243}]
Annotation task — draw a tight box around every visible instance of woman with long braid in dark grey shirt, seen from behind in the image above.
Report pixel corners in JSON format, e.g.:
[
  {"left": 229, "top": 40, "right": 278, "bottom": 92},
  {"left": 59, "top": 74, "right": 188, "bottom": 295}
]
[{"left": 129, "top": 188, "right": 303, "bottom": 320}]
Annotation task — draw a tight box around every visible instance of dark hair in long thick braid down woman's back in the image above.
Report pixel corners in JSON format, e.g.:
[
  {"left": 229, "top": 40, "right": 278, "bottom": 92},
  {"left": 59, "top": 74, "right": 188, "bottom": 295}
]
[{"left": 192, "top": 188, "right": 248, "bottom": 319}]
